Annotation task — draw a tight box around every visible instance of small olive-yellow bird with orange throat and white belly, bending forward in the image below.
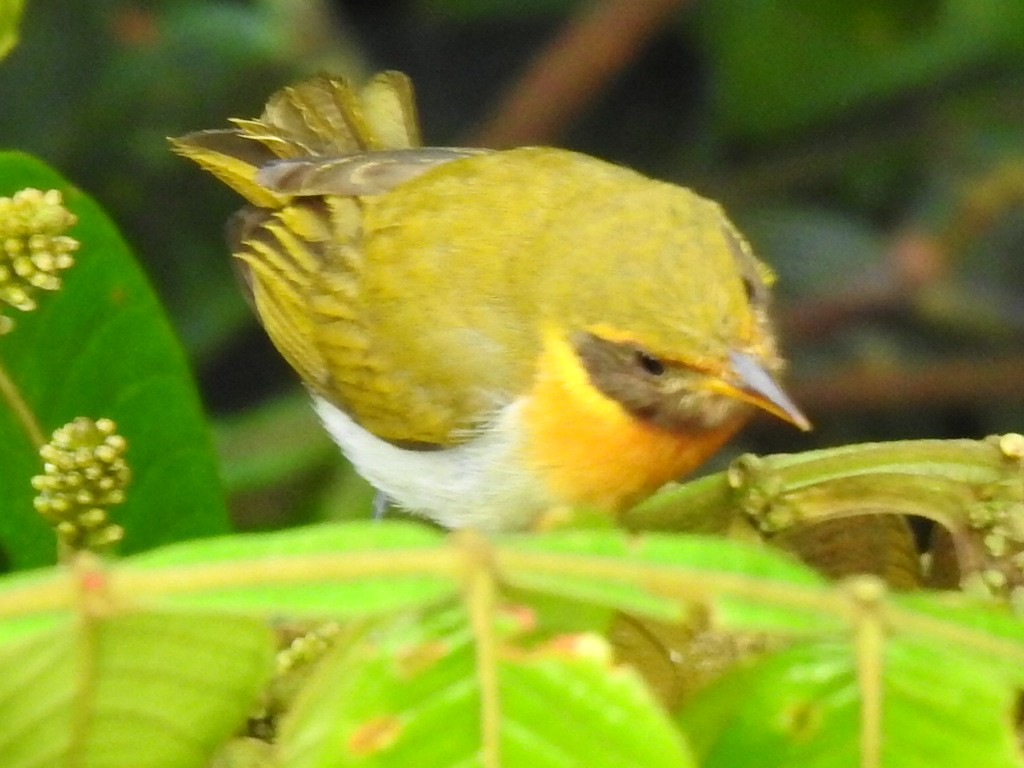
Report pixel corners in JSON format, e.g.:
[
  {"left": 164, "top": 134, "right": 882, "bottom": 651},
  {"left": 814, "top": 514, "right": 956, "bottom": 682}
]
[{"left": 172, "top": 72, "right": 809, "bottom": 530}]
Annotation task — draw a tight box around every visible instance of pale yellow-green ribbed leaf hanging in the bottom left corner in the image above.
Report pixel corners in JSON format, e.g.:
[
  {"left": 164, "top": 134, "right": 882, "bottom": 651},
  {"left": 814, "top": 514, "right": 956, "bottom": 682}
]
[{"left": 0, "top": 612, "right": 273, "bottom": 768}]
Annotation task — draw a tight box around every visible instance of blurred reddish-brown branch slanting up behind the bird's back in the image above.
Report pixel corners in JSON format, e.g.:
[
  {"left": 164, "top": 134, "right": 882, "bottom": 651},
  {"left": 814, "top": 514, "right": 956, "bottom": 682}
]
[{"left": 469, "top": 0, "right": 686, "bottom": 148}]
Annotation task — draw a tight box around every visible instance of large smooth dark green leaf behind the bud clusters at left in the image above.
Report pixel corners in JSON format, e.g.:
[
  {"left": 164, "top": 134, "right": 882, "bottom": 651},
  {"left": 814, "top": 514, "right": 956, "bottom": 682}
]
[{"left": 0, "top": 153, "right": 227, "bottom": 567}]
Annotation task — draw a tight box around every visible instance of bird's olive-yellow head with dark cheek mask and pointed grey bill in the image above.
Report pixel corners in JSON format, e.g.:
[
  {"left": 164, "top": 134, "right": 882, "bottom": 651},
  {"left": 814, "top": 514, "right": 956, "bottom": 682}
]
[{"left": 544, "top": 181, "right": 810, "bottom": 432}]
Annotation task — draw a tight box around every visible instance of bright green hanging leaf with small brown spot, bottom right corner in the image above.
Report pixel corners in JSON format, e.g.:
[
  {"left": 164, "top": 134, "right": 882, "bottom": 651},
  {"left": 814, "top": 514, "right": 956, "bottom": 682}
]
[{"left": 680, "top": 637, "right": 1024, "bottom": 768}]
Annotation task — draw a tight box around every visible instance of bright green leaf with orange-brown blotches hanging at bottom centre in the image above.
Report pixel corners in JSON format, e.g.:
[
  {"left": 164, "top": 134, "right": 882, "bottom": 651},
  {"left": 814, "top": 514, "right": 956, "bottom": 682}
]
[{"left": 280, "top": 607, "right": 692, "bottom": 768}]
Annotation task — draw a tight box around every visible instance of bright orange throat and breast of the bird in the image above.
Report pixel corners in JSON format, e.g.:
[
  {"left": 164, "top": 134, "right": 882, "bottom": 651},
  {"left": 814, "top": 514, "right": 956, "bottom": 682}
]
[{"left": 523, "top": 335, "right": 743, "bottom": 511}]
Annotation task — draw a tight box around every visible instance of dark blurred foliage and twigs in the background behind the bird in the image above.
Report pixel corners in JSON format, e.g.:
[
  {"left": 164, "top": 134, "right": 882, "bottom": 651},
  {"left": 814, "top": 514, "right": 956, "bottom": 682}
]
[{"left": 0, "top": 0, "right": 1024, "bottom": 527}]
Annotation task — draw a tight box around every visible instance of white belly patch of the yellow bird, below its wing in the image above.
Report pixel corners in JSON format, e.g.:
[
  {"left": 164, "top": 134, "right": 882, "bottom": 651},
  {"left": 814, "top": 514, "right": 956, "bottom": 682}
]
[{"left": 313, "top": 395, "right": 553, "bottom": 530}]
